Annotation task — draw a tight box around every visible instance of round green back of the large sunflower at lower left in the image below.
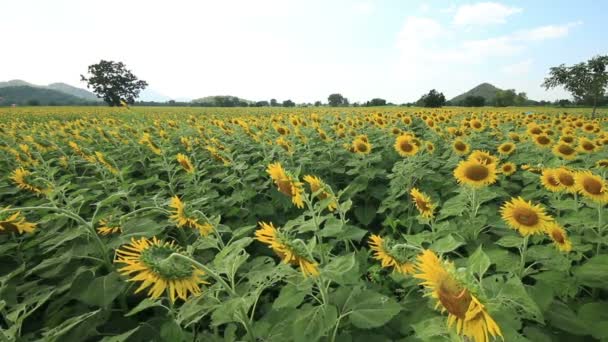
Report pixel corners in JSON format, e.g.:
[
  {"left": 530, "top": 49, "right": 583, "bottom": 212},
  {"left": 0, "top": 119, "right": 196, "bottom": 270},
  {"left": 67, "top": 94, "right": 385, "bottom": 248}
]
[{"left": 139, "top": 245, "right": 193, "bottom": 279}]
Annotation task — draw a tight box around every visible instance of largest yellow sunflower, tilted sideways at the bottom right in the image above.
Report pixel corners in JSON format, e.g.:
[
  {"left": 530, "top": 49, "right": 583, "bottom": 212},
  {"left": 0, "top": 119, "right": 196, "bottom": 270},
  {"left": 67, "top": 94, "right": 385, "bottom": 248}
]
[{"left": 414, "top": 250, "right": 502, "bottom": 342}]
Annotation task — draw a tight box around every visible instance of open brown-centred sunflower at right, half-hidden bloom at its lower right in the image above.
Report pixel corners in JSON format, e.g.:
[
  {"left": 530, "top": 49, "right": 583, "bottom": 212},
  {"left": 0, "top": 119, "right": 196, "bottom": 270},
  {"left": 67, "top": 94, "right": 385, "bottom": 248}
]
[{"left": 500, "top": 197, "right": 552, "bottom": 236}]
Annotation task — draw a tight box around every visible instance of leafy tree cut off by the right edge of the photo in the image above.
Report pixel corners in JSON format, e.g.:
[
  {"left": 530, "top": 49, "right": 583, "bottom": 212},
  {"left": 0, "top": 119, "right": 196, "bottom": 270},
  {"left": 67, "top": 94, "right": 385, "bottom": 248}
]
[{"left": 542, "top": 55, "right": 608, "bottom": 117}]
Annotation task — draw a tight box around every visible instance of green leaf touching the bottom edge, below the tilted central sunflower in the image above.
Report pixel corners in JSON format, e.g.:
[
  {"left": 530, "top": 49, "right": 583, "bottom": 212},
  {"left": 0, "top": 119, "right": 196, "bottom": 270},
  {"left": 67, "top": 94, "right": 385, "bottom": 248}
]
[{"left": 293, "top": 305, "right": 338, "bottom": 342}]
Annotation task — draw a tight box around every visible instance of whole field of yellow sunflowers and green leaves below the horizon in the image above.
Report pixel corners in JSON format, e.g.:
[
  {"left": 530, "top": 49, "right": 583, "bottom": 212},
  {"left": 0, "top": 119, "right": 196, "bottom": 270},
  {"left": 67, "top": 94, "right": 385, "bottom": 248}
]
[{"left": 0, "top": 107, "right": 608, "bottom": 342}]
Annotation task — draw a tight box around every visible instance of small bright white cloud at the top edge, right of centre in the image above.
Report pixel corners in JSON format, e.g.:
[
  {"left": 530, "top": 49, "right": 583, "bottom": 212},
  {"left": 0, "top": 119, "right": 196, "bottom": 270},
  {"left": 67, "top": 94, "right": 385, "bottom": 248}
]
[{"left": 454, "top": 2, "right": 522, "bottom": 26}]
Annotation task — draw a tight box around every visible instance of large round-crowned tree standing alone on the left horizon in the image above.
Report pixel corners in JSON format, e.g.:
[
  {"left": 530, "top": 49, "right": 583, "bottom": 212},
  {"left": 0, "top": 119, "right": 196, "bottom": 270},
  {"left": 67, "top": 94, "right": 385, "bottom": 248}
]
[{"left": 80, "top": 59, "right": 148, "bottom": 106}]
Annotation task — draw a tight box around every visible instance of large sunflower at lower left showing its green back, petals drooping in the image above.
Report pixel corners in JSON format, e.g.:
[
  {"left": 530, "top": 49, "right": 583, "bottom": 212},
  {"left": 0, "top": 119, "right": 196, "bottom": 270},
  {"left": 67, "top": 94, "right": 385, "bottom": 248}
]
[{"left": 114, "top": 237, "right": 208, "bottom": 302}]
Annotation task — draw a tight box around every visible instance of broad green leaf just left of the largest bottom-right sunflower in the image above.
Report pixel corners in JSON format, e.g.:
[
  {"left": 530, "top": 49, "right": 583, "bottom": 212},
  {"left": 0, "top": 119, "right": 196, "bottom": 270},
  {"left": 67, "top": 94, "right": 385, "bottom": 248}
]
[{"left": 349, "top": 290, "right": 401, "bottom": 329}]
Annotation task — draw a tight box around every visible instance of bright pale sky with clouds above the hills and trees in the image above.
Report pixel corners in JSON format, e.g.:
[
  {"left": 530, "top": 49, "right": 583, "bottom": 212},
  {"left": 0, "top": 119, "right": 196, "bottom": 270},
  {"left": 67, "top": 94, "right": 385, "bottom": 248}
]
[{"left": 0, "top": 0, "right": 608, "bottom": 103}]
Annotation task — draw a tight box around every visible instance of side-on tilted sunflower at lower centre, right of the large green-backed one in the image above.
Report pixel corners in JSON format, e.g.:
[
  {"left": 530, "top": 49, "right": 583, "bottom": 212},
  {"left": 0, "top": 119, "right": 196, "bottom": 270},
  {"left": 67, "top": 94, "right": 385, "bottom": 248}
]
[{"left": 255, "top": 222, "right": 319, "bottom": 277}]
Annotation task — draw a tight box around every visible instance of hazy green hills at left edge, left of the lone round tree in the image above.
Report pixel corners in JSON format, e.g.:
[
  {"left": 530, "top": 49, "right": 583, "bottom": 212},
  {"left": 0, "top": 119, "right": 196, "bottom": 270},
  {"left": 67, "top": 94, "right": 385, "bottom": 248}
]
[{"left": 0, "top": 86, "right": 87, "bottom": 106}]
